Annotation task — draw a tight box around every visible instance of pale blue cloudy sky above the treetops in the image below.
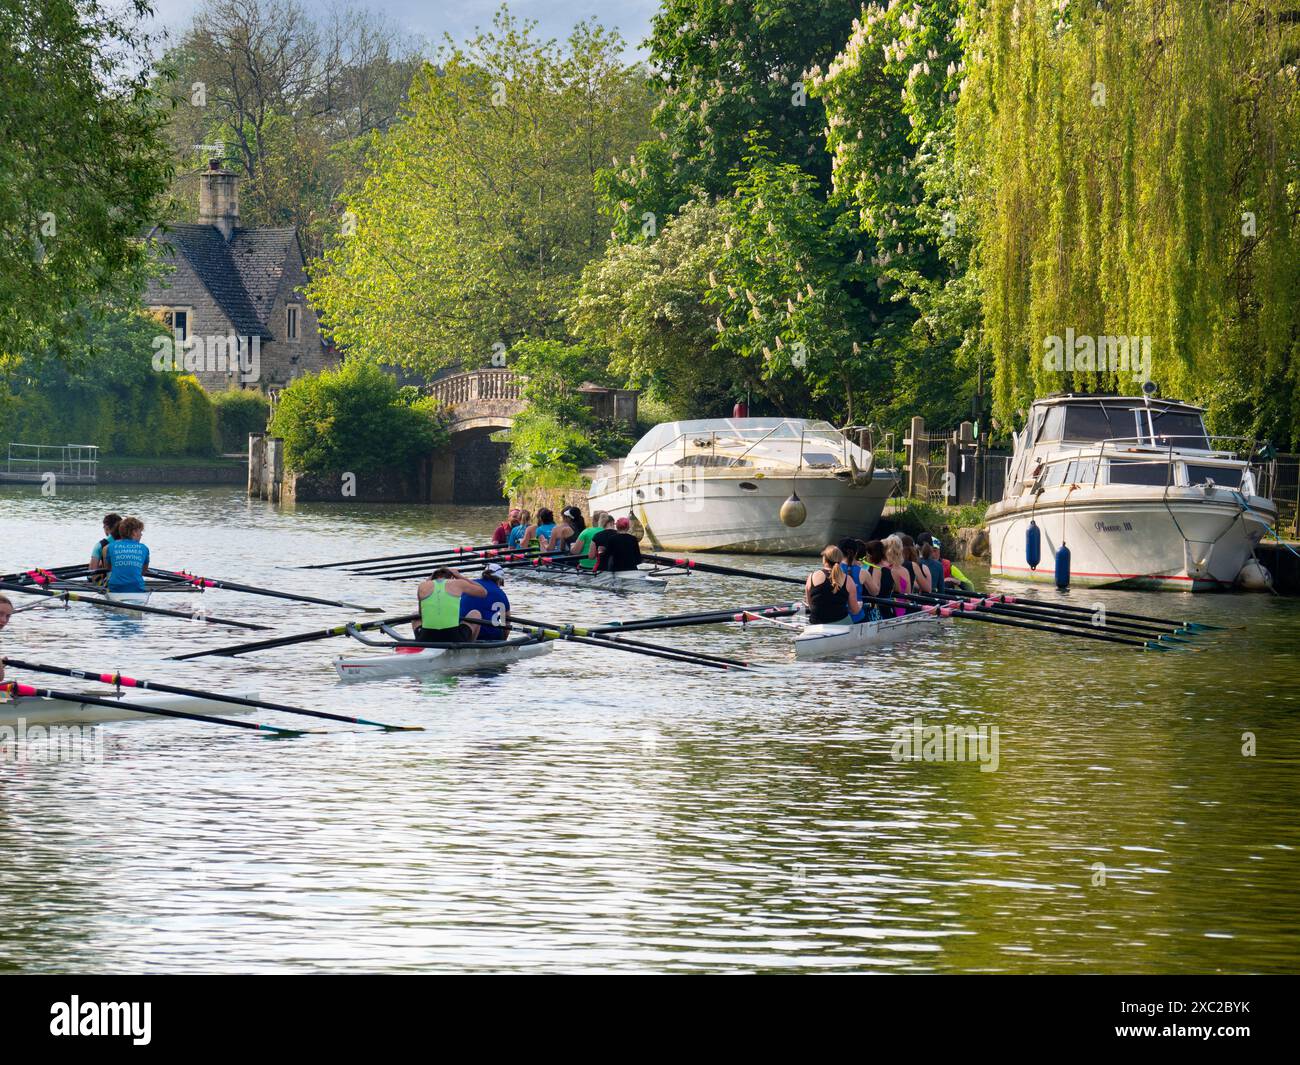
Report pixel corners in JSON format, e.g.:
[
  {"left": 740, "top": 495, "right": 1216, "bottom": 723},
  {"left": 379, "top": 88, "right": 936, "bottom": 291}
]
[{"left": 152, "top": 0, "right": 659, "bottom": 57}]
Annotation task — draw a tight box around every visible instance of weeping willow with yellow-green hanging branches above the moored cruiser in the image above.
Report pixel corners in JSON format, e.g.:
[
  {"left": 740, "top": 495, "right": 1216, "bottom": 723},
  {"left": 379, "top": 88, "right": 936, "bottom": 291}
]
[{"left": 957, "top": 0, "right": 1300, "bottom": 445}]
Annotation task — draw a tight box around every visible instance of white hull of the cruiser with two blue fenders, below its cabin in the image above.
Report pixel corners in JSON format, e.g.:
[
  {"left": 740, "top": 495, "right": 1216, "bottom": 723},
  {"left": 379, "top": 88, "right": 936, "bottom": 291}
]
[{"left": 987, "top": 489, "right": 1277, "bottom": 592}]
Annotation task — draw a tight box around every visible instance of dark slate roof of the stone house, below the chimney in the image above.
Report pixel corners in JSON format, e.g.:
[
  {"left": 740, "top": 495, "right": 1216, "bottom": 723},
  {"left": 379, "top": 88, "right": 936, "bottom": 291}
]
[{"left": 148, "top": 222, "right": 298, "bottom": 341}]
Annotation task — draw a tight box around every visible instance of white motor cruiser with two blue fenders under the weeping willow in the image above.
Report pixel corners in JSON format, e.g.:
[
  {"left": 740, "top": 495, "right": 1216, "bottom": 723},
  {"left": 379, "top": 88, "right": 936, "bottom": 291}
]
[{"left": 985, "top": 395, "right": 1278, "bottom": 592}]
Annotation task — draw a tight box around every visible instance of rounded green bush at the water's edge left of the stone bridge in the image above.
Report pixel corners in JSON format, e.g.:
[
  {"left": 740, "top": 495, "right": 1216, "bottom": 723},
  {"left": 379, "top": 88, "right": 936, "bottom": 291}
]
[{"left": 268, "top": 360, "right": 447, "bottom": 473}]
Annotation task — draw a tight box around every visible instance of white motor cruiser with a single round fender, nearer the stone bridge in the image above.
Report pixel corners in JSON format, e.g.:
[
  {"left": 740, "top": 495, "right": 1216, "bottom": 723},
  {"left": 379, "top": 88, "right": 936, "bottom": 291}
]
[{"left": 589, "top": 417, "right": 897, "bottom": 554}]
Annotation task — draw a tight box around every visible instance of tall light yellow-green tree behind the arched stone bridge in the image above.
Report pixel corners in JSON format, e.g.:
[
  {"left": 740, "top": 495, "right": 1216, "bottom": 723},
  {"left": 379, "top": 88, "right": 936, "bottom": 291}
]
[{"left": 302, "top": 8, "right": 649, "bottom": 372}]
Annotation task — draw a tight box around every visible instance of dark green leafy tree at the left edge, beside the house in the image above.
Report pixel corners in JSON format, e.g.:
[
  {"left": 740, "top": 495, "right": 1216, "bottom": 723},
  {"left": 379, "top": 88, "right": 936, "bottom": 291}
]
[{"left": 0, "top": 0, "right": 170, "bottom": 368}]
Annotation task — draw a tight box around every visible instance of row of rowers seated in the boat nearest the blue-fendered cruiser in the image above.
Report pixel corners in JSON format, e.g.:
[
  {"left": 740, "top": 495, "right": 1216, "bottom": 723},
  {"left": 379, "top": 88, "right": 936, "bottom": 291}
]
[{"left": 803, "top": 533, "right": 974, "bottom": 625}]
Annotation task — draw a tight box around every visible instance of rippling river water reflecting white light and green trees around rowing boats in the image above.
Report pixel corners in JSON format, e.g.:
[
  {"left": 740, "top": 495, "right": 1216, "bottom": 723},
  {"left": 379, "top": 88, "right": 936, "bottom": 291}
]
[{"left": 0, "top": 486, "right": 1300, "bottom": 973}]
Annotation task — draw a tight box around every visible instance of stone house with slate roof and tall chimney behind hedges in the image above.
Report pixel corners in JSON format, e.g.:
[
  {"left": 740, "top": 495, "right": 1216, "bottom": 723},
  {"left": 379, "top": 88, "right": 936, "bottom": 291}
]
[{"left": 144, "top": 160, "right": 338, "bottom": 391}]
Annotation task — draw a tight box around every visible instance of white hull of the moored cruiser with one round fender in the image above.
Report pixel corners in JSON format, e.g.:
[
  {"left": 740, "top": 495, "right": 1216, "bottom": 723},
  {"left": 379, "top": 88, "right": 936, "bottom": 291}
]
[{"left": 589, "top": 472, "right": 896, "bottom": 555}]
